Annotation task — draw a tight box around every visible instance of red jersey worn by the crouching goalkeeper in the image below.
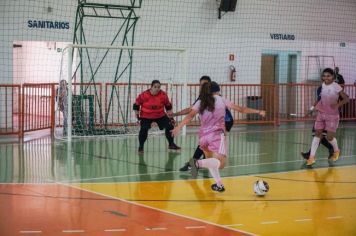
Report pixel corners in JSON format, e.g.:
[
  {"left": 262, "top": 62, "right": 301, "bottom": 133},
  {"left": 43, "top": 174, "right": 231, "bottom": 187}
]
[{"left": 135, "top": 89, "right": 172, "bottom": 119}]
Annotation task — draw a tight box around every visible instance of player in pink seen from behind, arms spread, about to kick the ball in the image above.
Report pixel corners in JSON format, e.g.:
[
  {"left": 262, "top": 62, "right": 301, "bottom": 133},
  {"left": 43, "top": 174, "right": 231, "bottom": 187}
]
[{"left": 172, "top": 82, "right": 265, "bottom": 192}]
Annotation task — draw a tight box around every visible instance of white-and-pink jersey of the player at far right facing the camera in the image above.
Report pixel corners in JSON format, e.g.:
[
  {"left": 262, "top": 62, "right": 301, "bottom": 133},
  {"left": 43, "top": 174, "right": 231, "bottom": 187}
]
[{"left": 316, "top": 82, "right": 342, "bottom": 115}]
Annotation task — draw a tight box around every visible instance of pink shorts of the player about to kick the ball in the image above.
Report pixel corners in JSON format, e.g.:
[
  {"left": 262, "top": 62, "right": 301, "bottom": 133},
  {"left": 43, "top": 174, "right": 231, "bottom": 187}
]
[{"left": 199, "top": 131, "right": 227, "bottom": 156}]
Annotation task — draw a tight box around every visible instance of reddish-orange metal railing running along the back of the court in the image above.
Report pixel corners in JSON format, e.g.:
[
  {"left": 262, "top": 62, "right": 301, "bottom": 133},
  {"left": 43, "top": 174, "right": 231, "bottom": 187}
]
[{"left": 0, "top": 83, "right": 356, "bottom": 137}]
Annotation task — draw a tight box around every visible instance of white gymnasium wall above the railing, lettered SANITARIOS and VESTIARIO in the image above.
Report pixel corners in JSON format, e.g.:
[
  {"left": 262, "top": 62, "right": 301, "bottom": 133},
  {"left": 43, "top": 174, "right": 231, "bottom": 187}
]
[{"left": 0, "top": 0, "right": 356, "bottom": 83}]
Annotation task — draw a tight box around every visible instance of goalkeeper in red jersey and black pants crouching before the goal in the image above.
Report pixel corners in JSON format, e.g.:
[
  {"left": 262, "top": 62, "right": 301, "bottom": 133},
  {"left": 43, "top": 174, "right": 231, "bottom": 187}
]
[{"left": 133, "top": 80, "right": 180, "bottom": 153}]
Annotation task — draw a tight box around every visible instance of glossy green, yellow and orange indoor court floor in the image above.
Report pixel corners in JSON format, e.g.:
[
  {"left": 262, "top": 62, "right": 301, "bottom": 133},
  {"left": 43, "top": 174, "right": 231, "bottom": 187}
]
[{"left": 0, "top": 123, "right": 356, "bottom": 235}]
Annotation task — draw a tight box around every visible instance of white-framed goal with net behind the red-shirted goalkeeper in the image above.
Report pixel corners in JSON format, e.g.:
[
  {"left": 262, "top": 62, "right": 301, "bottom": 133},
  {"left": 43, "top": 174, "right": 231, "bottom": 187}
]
[{"left": 55, "top": 45, "right": 186, "bottom": 138}]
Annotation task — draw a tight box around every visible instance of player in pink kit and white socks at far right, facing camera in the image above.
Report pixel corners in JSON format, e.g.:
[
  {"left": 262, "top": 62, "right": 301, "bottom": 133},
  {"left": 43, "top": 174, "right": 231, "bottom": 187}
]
[{"left": 306, "top": 68, "right": 349, "bottom": 166}]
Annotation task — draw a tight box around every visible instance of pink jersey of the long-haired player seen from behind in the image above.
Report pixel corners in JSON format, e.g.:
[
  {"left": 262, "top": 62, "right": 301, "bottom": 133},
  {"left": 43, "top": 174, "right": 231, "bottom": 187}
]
[{"left": 192, "top": 95, "right": 232, "bottom": 136}]
